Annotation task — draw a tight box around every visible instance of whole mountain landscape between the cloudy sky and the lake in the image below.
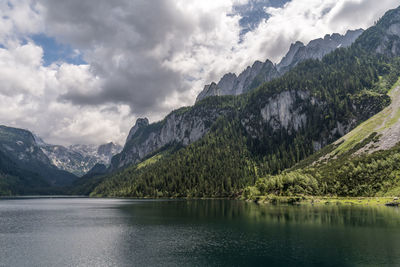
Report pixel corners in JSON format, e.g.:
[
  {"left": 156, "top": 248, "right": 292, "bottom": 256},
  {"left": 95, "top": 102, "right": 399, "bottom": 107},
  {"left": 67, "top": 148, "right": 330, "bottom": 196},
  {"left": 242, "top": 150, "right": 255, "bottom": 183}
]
[{"left": 0, "top": 5, "right": 400, "bottom": 200}]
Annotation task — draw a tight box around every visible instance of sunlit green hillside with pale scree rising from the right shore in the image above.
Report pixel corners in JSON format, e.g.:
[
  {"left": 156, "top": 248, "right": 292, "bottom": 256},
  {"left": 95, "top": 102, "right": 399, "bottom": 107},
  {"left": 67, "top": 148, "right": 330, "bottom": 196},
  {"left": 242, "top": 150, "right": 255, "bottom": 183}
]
[{"left": 245, "top": 77, "right": 400, "bottom": 199}]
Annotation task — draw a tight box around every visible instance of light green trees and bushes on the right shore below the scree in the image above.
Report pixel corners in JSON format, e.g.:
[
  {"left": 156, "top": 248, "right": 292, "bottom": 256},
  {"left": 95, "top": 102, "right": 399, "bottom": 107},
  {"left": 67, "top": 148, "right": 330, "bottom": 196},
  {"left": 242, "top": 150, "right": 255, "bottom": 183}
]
[{"left": 244, "top": 145, "right": 400, "bottom": 199}]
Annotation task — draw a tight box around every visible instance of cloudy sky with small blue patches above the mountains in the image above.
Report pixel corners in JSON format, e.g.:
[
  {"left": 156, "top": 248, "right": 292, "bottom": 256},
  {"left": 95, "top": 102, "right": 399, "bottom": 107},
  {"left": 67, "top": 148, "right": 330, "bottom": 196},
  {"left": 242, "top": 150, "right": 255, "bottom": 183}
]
[{"left": 0, "top": 0, "right": 399, "bottom": 145}]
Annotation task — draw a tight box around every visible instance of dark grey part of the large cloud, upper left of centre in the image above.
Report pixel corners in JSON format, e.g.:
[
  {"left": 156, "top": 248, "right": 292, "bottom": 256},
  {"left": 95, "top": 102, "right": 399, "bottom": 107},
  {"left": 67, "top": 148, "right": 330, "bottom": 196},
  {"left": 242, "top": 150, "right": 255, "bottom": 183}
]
[{"left": 43, "top": 0, "right": 197, "bottom": 114}]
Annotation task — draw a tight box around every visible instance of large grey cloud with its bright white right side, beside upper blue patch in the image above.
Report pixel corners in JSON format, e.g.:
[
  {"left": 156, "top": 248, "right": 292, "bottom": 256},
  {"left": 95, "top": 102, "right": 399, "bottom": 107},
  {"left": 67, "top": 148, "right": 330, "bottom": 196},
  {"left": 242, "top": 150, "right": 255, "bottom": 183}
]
[{"left": 38, "top": 0, "right": 244, "bottom": 118}]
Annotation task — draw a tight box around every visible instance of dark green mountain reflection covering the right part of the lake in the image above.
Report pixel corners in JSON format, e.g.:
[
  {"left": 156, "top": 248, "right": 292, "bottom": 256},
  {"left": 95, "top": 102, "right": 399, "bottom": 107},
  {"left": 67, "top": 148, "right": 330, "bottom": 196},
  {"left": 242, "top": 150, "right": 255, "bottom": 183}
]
[{"left": 116, "top": 200, "right": 400, "bottom": 266}]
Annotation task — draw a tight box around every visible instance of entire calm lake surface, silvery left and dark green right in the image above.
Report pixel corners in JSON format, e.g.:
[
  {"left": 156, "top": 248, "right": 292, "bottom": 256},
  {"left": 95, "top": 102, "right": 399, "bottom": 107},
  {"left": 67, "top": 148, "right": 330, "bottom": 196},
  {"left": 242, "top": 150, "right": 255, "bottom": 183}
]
[{"left": 0, "top": 198, "right": 400, "bottom": 266}]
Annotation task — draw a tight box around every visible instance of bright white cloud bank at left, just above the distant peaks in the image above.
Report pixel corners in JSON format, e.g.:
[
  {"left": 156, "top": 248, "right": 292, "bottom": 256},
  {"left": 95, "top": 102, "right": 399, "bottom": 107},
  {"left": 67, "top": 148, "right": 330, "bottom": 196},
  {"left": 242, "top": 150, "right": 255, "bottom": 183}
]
[{"left": 0, "top": 40, "right": 133, "bottom": 144}]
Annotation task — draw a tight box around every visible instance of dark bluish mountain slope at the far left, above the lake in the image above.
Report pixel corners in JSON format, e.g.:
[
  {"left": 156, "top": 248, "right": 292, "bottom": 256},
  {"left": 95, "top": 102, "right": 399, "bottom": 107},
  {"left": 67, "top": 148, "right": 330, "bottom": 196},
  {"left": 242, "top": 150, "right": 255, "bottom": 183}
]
[{"left": 0, "top": 126, "right": 77, "bottom": 194}]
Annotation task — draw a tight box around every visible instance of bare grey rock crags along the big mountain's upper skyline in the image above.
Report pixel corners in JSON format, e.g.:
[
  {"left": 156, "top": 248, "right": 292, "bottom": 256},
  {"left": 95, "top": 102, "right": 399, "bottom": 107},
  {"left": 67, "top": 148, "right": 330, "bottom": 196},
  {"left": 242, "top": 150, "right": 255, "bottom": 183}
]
[{"left": 110, "top": 30, "right": 363, "bottom": 174}]
